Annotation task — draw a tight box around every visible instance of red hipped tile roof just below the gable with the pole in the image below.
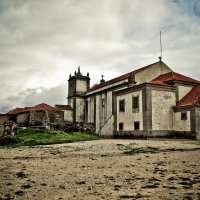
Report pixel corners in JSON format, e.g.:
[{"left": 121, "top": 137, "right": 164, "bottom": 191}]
[{"left": 150, "top": 72, "right": 200, "bottom": 85}]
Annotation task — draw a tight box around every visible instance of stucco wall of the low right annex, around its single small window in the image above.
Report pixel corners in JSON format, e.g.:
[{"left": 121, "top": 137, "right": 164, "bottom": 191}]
[{"left": 174, "top": 111, "right": 191, "bottom": 131}]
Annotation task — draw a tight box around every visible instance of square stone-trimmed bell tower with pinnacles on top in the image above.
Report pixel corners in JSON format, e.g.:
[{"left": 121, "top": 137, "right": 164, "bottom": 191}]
[{"left": 68, "top": 67, "right": 90, "bottom": 122}]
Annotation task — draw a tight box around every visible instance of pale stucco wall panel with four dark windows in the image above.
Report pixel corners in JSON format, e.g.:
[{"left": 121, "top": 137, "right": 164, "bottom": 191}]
[{"left": 117, "top": 91, "right": 143, "bottom": 131}]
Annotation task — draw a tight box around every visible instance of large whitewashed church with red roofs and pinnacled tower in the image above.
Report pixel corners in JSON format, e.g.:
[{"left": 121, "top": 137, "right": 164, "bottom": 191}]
[{"left": 68, "top": 61, "right": 200, "bottom": 138}]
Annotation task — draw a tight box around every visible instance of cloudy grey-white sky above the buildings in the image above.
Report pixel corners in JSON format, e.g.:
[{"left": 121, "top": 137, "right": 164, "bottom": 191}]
[{"left": 0, "top": 0, "right": 200, "bottom": 113}]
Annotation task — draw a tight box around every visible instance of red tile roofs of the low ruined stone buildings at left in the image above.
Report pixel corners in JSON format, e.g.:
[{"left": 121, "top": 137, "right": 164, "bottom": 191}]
[{"left": 6, "top": 103, "right": 58, "bottom": 115}]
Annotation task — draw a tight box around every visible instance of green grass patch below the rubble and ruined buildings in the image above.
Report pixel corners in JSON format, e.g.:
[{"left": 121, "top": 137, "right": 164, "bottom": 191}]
[{"left": 1, "top": 129, "right": 102, "bottom": 147}]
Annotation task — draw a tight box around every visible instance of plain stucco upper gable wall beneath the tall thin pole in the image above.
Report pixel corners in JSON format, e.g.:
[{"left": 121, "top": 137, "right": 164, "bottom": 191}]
[{"left": 135, "top": 62, "right": 171, "bottom": 85}]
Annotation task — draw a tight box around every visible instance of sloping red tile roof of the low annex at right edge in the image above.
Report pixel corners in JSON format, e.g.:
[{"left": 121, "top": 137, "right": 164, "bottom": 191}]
[{"left": 177, "top": 85, "right": 200, "bottom": 107}]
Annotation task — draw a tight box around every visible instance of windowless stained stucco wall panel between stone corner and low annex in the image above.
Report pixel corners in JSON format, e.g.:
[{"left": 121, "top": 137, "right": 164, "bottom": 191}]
[{"left": 152, "top": 90, "right": 176, "bottom": 130}]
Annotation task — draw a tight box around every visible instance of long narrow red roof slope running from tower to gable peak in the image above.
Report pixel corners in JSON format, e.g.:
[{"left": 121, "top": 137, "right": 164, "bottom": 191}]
[{"left": 89, "top": 61, "right": 160, "bottom": 92}]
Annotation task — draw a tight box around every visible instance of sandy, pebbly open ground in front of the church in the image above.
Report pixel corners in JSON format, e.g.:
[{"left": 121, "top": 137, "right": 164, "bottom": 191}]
[{"left": 0, "top": 139, "right": 200, "bottom": 200}]
